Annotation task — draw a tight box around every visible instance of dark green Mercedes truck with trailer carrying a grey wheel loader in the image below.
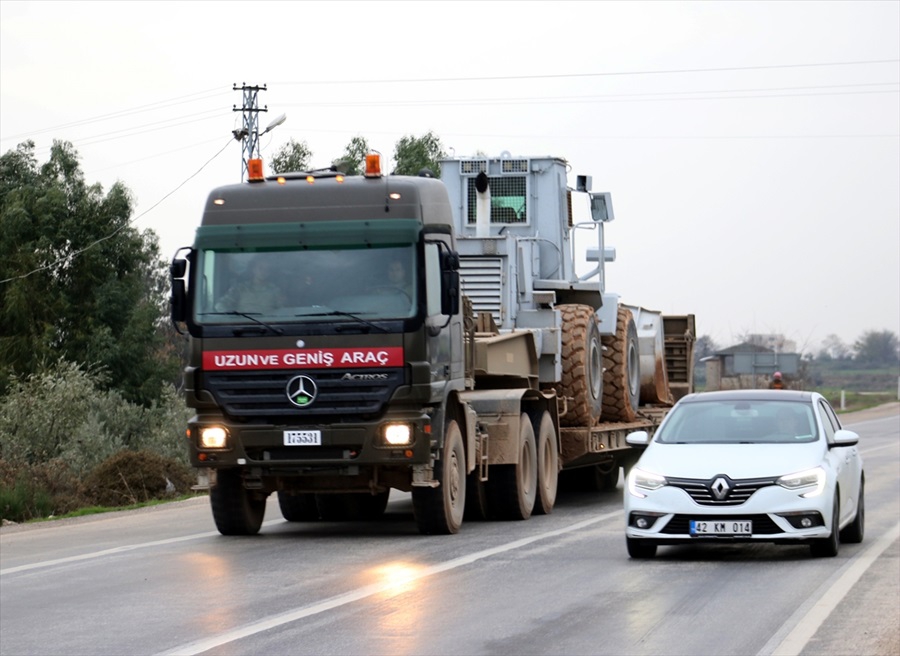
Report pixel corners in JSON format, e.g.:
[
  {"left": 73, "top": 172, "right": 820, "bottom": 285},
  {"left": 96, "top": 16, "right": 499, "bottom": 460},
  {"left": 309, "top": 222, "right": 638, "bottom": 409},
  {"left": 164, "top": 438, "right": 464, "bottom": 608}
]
[{"left": 171, "top": 155, "right": 695, "bottom": 535}]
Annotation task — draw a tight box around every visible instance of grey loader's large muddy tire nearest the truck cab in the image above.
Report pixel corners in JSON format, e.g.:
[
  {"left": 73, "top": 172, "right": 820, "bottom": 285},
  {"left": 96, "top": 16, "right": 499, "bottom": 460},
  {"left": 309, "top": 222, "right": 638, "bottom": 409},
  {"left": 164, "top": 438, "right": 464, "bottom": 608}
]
[{"left": 557, "top": 305, "right": 604, "bottom": 426}]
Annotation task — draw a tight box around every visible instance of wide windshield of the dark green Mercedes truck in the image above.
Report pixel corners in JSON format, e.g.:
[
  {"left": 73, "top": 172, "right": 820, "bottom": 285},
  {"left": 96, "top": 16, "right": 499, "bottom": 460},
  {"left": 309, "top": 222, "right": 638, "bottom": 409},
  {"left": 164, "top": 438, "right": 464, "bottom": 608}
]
[{"left": 193, "top": 245, "right": 416, "bottom": 324}]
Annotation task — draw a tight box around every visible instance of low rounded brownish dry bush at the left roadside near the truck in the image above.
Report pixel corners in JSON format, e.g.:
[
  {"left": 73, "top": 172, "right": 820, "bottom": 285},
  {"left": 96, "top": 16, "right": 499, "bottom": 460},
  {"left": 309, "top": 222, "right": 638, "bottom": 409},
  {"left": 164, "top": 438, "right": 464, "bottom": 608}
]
[{"left": 84, "top": 450, "right": 194, "bottom": 506}]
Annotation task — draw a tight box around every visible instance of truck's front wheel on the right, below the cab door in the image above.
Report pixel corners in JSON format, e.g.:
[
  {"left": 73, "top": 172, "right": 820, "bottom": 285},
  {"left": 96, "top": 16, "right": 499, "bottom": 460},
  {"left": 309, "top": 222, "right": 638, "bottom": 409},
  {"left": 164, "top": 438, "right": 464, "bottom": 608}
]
[{"left": 412, "top": 419, "right": 466, "bottom": 535}]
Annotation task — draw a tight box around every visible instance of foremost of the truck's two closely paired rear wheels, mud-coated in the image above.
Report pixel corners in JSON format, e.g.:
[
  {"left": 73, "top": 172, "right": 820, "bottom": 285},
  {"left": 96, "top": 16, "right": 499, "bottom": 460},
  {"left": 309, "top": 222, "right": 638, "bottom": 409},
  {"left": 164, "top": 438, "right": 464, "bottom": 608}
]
[{"left": 488, "top": 413, "right": 537, "bottom": 519}]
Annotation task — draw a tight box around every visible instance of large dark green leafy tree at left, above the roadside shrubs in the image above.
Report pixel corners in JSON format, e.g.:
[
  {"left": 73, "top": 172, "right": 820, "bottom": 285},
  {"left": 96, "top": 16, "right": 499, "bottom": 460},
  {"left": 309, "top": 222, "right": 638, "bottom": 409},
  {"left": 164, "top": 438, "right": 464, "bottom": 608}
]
[{"left": 0, "top": 141, "right": 180, "bottom": 405}]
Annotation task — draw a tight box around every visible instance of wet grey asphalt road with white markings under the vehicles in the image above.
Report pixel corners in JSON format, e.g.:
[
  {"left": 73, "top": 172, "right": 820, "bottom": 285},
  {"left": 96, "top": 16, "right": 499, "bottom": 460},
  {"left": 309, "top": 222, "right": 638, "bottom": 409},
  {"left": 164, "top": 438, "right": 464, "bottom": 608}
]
[{"left": 0, "top": 404, "right": 900, "bottom": 656}]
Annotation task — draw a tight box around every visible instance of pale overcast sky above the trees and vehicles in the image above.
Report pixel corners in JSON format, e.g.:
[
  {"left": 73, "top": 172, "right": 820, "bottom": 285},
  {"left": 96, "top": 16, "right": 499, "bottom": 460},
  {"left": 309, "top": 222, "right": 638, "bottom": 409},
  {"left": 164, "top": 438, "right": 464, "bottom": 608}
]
[{"left": 0, "top": 0, "right": 900, "bottom": 353}]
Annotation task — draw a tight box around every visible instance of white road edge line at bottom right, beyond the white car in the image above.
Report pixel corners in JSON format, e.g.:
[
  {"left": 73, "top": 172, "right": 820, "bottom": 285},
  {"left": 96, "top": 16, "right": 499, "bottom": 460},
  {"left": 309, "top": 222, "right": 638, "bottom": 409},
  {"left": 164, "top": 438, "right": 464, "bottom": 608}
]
[{"left": 757, "top": 523, "right": 900, "bottom": 656}]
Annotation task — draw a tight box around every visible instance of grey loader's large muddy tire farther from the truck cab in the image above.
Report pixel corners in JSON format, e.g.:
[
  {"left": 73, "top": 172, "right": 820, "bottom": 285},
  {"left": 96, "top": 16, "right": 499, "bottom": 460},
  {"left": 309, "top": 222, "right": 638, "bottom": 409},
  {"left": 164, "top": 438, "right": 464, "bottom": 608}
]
[{"left": 603, "top": 307, "right": 641, "bottom": 422}]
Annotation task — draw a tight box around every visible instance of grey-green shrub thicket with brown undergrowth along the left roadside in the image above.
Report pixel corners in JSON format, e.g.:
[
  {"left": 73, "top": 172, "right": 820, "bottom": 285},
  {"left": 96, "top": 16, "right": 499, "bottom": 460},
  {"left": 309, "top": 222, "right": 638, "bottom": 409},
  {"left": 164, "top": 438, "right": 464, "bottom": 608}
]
[{"left": 0, "top": 360, "right": 193, "bottom": 521}]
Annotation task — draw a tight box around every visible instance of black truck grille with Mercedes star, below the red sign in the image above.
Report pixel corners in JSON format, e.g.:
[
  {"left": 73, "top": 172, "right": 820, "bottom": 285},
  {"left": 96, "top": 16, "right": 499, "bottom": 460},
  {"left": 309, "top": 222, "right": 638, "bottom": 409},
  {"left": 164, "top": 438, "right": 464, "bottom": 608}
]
[{"left": 203, "top": 368, "right": 404, "bottom": 421}]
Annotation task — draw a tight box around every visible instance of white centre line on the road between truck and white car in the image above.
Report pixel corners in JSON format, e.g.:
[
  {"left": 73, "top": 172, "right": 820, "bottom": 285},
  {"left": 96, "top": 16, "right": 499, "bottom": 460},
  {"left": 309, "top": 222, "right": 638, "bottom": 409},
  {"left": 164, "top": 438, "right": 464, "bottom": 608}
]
[{"left": 163, "top": 510, "right": 624, "bottom": 656}]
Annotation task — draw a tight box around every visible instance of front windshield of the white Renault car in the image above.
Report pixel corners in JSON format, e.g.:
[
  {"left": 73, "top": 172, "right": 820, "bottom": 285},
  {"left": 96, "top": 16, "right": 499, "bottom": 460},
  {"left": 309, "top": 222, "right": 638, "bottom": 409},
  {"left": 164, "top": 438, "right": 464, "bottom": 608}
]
[{"left": 655, "top": 400, "right": 818, "bottom": 444}]
